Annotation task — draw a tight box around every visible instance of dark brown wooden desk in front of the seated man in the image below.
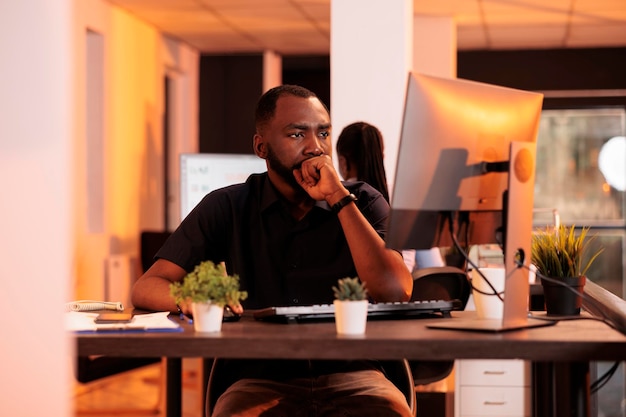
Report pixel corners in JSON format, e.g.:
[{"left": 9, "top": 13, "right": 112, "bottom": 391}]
[{"left": 77, "top": 312, "right": 626, "bottom": 417}]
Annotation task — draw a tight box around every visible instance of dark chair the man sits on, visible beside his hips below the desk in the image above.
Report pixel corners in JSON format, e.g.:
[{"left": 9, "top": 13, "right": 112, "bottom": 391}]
[{"left": 205, "top": 358, "right": 417, "bottom": 417}]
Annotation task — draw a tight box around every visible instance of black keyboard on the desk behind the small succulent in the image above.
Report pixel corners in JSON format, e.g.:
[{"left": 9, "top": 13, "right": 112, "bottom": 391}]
[{"left": 252, "top": 300, "right": 460, "bottom": 323}]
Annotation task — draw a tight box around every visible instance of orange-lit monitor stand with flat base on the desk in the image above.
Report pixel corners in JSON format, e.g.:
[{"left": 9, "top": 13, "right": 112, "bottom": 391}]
[{"left": 427, "top": 142, "right": 554, "bottom": 332}]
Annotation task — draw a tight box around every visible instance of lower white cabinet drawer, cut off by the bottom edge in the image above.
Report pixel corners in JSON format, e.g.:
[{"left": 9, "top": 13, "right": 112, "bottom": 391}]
[{"left": 459, "top": 386, "right": 531, "bottom": 417}]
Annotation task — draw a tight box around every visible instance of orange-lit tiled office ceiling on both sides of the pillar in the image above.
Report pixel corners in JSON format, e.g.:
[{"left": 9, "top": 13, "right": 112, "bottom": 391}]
[{"left": 109, "top": 0, "right": 626, "bottom": 55}]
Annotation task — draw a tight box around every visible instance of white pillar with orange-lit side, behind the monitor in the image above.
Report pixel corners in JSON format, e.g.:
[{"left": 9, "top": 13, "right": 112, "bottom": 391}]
[{"left": 330, "top": 0, "right": 456, "bottom": 192}]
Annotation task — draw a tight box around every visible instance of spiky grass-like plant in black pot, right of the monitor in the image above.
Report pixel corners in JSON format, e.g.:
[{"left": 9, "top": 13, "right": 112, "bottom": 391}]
[{"left": 531, "top": 225, "right": 603, "bottom": 316}]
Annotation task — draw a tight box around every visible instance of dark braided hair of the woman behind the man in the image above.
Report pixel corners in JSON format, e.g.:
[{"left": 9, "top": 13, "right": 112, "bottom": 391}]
[{"left": 337, "top": 122, "right": 389, "bottom": 201}]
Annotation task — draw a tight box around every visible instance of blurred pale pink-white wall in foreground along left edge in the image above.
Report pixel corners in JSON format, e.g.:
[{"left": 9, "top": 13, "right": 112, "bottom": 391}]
[{"left": 0, "top": 0, "right": 74, "bottom": 417}]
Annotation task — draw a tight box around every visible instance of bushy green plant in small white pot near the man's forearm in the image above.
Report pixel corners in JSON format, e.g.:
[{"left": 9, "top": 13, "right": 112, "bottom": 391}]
[{"left": 170, "top": 261, "right": 248, "bottom": 332}]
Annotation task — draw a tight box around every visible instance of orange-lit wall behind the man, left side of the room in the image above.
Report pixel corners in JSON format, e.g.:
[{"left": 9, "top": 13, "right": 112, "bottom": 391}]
[{"left": 72, "top": 0, "right": 199, "bottom": 302}]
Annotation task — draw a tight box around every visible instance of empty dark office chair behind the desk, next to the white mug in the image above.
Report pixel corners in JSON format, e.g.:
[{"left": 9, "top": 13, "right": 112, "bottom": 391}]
[{"left": 409, "top": 266, "right": 471, "bottom": 385}]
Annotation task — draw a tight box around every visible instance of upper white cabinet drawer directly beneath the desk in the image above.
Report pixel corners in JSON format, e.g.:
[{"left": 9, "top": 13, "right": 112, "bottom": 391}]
[{"left": 459, "top": 359, "right": 530, "bottom": 387}]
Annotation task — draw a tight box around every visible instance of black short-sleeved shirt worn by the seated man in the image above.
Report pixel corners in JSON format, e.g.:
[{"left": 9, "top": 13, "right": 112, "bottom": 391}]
[{"left": 156, "top": 173, "right": 389, "bottom": 309}]
